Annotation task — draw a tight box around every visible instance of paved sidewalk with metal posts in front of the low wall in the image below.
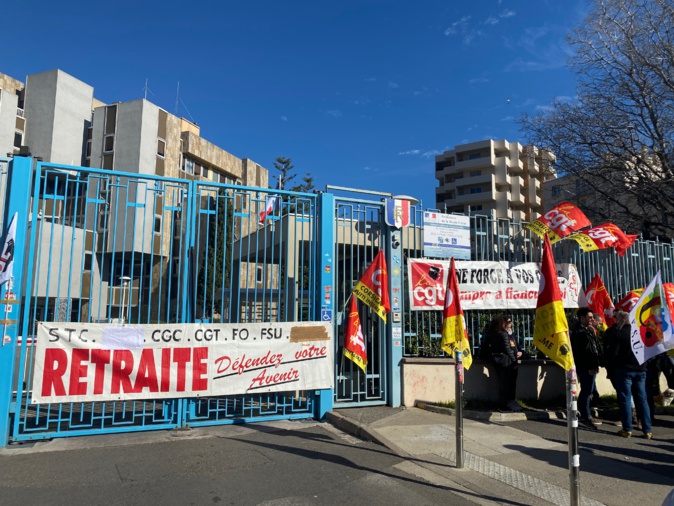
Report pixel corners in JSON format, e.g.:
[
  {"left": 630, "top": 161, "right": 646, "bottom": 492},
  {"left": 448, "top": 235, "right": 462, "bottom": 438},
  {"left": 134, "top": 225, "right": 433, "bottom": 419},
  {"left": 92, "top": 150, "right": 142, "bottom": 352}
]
[{"left": 328, "top": 404, "right": 674, "bottom": 506}]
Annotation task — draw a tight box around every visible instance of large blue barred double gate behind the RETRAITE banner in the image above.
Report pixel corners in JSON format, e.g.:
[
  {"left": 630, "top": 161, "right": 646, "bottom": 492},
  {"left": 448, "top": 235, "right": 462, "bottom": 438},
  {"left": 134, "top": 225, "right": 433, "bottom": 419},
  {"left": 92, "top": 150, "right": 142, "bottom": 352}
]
[{"left": 0, "top": 157, "right": 330, "bottom": 444}]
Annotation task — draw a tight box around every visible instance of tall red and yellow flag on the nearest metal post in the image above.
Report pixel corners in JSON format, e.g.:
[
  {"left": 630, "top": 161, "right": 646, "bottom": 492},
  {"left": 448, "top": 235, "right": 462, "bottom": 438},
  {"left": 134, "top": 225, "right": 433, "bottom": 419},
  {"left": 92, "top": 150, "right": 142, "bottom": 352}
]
[{"left": 534, "top": 235, "right": 573, "bottom": 371}]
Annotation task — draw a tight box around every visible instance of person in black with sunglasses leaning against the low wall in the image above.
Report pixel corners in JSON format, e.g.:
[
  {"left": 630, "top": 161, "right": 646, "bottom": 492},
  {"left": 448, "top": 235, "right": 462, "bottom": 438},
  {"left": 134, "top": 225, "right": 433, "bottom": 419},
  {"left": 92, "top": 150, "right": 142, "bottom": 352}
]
[{"left": 487, "top": 316, "right": 522, "bottom": 411}]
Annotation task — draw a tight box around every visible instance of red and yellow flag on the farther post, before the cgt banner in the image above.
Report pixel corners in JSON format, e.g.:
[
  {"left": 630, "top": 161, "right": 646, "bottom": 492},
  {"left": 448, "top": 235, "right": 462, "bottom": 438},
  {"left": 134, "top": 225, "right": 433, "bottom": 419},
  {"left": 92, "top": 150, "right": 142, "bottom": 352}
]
[{"left": 441, "top": 257, "right": 473, "bottom": 369}]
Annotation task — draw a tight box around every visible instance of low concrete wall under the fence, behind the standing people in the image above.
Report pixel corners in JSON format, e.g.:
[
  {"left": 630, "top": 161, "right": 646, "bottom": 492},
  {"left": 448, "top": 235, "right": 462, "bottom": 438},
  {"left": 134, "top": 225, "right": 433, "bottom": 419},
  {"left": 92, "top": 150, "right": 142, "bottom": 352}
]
[{"left": 402, "top": 358, "right": 667, "bottom": 406}]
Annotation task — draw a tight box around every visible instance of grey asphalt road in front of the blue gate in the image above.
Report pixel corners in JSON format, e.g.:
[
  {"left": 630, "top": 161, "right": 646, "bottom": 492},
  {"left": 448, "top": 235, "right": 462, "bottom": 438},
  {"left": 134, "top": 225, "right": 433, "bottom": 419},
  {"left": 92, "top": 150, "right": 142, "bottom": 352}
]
[{"left": 0, "top": 422, "right": 472, "bottom": 506}]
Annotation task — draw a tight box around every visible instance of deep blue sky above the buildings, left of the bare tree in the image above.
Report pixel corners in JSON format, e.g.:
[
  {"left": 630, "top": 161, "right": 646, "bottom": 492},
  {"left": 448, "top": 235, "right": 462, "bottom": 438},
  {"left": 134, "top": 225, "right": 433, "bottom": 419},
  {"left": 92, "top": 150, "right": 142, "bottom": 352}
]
[{"left": 0, "top": 0, "right": 587, "bottom": 207}]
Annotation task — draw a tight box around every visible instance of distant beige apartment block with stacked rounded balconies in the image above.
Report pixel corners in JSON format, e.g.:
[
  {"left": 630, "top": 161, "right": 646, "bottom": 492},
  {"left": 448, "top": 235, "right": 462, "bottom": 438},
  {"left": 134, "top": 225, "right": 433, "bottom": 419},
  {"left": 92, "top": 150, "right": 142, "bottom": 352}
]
[{"left": 435, "top": 139, "right": 557, "bottom": 221}]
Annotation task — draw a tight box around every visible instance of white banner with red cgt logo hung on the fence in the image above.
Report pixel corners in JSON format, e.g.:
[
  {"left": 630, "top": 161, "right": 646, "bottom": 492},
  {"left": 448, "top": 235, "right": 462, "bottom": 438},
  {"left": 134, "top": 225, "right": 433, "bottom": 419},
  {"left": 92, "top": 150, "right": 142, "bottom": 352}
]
[{"left": 407, "top": 259, "right": 581, "bottom": 311}]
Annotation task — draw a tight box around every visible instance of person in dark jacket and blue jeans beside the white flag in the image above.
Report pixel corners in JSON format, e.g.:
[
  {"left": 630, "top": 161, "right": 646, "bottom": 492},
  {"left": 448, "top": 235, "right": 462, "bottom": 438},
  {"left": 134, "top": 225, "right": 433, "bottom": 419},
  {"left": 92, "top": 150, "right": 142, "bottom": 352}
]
[{"left": 606, "top": 311, "right": 653, "bottom": 439}]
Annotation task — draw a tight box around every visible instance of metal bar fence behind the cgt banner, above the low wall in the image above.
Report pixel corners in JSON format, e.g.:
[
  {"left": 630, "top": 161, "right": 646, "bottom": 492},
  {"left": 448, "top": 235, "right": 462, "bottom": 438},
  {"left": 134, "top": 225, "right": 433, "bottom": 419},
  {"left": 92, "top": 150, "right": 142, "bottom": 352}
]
[{"left": 403, "top": 208, "right": 674, "bottom": 357}]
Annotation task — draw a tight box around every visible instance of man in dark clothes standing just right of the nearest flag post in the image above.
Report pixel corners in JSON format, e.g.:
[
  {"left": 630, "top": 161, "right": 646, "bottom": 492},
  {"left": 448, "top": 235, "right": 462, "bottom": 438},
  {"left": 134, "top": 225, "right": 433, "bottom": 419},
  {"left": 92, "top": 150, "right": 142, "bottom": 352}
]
[{"left": 570, "top": 307, "right": 602, "bottom": 428}]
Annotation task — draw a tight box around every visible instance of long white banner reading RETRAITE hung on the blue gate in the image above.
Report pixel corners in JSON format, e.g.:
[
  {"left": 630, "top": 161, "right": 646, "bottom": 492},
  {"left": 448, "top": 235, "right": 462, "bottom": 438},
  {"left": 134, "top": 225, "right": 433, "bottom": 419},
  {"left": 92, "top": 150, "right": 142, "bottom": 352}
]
[{"left": 31, "top": 322, "right": 334, "bottom": 404}]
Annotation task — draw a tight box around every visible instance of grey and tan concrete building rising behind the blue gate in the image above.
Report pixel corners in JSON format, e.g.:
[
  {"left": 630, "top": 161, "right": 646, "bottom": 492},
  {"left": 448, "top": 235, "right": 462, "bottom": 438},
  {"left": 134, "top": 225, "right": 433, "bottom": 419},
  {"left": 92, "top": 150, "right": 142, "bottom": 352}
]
[{"left": 0, "top": 70, "right": 268, "bottom": 321}]
